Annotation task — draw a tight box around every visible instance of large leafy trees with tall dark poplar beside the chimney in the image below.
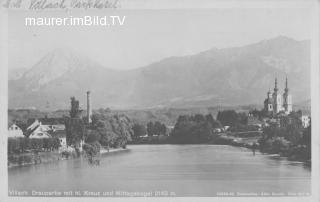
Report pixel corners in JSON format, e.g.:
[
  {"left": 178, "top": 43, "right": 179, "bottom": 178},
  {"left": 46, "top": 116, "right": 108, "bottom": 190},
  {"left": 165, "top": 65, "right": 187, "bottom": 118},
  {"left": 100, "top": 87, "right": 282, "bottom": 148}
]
[{"left": 65, "top": 97, "right": 133, "bottom": 154}]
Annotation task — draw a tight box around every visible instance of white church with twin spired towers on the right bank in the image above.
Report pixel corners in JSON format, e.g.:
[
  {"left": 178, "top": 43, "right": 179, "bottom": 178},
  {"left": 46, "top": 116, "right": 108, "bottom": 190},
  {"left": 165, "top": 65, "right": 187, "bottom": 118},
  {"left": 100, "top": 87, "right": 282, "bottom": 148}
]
[{"left": 264, "top": 78, "right": 292, "bottom": 114}]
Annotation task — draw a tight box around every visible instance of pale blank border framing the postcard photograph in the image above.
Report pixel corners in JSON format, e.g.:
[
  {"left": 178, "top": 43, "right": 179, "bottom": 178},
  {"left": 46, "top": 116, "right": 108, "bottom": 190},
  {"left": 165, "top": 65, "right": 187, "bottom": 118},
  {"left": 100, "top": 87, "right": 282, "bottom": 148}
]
[{"left": 0, "top": 0, "right": 320, "bottom": 202}]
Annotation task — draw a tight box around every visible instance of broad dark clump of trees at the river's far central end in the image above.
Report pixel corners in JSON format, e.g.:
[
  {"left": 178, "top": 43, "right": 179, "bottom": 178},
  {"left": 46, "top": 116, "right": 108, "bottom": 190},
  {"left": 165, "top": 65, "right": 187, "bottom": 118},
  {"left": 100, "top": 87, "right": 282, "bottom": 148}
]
[{"left": 171, "top": 114, "right": 222, "bottom": 144}]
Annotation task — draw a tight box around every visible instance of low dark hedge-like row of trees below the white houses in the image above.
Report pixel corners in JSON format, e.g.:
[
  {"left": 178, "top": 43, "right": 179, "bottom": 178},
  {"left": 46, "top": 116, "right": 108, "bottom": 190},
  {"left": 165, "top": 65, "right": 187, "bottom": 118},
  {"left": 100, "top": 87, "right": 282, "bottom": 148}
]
[{"left": 8, "top": 137, "right": 60, "bottom": 154}]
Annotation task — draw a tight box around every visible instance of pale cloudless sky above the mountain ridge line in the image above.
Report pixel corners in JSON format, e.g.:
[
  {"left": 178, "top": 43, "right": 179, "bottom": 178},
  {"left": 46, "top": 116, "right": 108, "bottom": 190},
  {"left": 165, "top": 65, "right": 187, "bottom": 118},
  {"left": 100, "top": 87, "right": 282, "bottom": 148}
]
[{"left": 8, "top": 5, "right": 311, "bottom": 70}]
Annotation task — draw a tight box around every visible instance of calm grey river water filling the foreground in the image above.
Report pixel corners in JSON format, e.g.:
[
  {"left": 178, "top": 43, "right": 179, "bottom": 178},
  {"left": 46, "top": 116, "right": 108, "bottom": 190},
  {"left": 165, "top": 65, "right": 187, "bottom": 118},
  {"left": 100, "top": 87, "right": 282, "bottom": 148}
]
[{"left": 8, "top": 145, "right": 311, "bottom": 196}]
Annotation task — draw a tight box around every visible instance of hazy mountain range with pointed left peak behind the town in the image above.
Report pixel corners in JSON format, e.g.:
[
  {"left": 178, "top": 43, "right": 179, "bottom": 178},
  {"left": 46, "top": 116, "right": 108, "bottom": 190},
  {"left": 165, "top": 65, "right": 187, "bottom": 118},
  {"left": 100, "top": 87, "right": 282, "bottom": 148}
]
[{"left": 9, "top": 36, "right": 310, "bottom": 110}]
